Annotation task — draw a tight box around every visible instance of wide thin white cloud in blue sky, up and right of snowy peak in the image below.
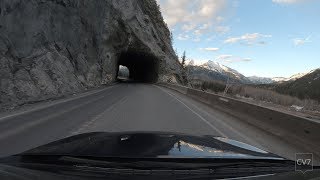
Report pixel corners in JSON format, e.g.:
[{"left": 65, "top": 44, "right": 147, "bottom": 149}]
[{"left": 224, "top": 33, "right": 272, "bottom": 45}]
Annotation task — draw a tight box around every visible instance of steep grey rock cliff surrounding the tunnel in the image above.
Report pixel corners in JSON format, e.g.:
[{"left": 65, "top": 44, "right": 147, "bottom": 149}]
[{"left": 0, "top": 0, "right": 180, "bottom": 108}]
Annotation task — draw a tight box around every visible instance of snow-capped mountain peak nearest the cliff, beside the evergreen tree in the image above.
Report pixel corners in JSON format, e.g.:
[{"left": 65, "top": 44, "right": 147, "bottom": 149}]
[{"left": 188, "top": 60, "right": 251, "bottom": 84}]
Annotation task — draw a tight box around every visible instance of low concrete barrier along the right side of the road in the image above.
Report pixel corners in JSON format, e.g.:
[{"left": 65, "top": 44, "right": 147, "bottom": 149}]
[{"left": 159, "top": 83, "right": 320, "bottom": 154}]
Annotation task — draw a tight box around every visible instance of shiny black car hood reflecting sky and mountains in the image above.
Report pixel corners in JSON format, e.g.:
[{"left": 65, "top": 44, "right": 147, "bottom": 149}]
[{"left": 20, "top": 132, "right": 283, "bottom": 159}]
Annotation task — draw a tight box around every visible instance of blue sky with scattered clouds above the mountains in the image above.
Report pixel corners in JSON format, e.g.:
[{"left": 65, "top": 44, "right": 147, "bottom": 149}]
[{"left": 157, "top": 0, "right": 320, "bottom": 77}]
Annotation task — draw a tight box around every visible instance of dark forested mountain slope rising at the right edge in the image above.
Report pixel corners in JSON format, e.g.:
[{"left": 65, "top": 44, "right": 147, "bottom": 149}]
[{"left": 274, "top": 68, "right": 320, "bottom": 102}]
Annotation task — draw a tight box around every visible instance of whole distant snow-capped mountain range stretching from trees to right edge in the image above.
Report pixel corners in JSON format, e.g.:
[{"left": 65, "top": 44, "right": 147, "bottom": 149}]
[{"left": 186, "top": 61, "right": 320, "bottom": 102}]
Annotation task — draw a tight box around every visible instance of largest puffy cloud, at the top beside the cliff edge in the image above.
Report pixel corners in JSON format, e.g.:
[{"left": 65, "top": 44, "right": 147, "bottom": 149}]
[{"left": 157, "top": 0, "right": 233, "bottom": 42}]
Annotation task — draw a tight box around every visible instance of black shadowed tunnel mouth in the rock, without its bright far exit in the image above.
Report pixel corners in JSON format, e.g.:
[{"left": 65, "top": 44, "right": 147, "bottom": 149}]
[{"left": 118, "top": 52, "right": 159, "bottom": 83}]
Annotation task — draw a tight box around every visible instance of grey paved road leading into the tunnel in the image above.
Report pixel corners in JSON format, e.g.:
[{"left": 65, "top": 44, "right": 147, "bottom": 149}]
[{"left": 0, "top": 83, "right": 312, "bottom": 162}]
